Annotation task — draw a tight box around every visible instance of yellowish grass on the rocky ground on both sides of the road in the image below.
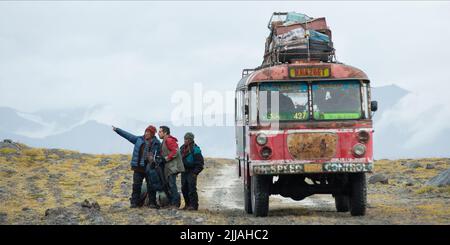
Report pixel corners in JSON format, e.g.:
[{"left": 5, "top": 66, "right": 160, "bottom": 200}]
[{"left": 0, "top": 145, "right": 450, "bottom": 224}]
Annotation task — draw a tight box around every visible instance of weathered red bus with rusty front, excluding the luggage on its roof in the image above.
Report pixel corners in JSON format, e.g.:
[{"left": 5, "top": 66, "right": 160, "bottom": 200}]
[{"left": 235, "top": 60, "right": 377, "bottom": 216}]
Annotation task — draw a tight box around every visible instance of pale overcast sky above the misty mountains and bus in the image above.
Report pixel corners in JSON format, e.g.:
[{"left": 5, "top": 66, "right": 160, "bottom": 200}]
[{"left": 0, "top": 1, "right": 450, "bottom": 127}]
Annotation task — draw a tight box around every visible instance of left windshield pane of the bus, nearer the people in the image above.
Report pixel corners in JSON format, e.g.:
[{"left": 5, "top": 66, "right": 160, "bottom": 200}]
[{"left": 259, "top": 82, "right": 309, "bottom": 121}]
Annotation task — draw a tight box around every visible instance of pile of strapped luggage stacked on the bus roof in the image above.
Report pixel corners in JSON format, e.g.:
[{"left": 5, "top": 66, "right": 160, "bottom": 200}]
[{"left": 263, "top": 12, "right": 334, "bottom": 64}]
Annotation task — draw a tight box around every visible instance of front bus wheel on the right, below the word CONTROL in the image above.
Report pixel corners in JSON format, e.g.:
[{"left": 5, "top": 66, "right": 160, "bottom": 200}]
[{"left": 349, "top": 173, "right": 367, "bottom": 216}]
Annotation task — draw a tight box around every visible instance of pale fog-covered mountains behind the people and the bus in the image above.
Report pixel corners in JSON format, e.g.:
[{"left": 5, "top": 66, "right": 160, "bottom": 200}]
[{"left": 0, "top": 85, "right": 450, "bottom": 159}]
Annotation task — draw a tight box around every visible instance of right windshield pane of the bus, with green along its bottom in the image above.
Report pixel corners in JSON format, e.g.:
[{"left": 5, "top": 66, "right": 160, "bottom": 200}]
[{"left": 312, "top": 80, "right": 362, "bottom": 120}]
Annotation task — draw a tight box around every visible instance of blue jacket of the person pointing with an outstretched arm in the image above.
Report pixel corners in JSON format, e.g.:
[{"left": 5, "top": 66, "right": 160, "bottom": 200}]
[{"left": 116, "top": 128, "right": 161, "bottom": 168}]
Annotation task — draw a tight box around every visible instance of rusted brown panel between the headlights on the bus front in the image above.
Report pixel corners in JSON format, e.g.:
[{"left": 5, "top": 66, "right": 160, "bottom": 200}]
[{"left": 287, "top": 133, "right": 337, "bottom": 160}]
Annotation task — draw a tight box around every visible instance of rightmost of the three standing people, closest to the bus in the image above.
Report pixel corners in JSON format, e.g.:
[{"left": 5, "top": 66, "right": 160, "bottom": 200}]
[{"left": 180, "top": 132, "right": 204, "bottom": 210}]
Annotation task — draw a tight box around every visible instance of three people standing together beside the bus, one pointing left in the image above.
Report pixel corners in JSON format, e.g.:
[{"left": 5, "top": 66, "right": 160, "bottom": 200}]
[{"left": 112, "top": 125, "right": 204, "bottom": 210}]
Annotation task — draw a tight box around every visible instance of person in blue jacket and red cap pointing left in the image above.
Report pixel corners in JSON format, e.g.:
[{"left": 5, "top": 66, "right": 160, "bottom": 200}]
[{"left": 112, "top": 125, "right": 161, "bottom": 208}]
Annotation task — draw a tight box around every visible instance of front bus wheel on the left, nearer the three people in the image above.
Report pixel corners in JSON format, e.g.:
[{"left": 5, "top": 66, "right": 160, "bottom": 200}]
[{"left": 250, "top": 175, "right": 272, "bottom": 217}]
